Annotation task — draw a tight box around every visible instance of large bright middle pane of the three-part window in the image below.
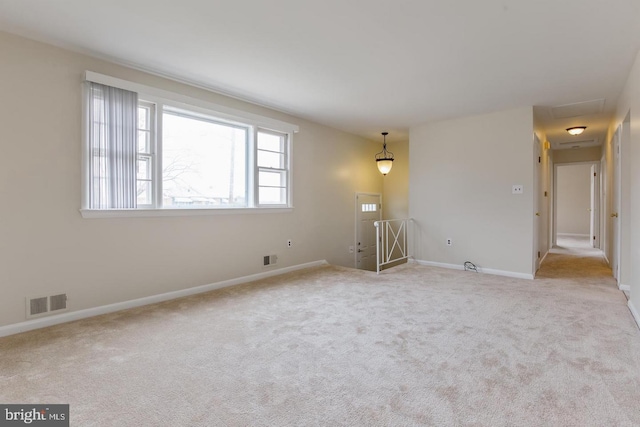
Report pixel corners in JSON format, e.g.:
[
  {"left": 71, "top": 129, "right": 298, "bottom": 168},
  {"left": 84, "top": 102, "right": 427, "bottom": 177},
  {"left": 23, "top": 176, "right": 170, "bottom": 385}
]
[{"left": 162, "top": 111, "right": 248, "bottom": 207}]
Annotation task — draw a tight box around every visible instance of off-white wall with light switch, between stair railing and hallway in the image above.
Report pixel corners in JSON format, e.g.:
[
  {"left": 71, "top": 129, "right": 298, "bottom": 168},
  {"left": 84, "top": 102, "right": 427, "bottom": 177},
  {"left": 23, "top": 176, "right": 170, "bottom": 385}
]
[{"left": 409, "top": 107, "right": 534, "bottom": 275}]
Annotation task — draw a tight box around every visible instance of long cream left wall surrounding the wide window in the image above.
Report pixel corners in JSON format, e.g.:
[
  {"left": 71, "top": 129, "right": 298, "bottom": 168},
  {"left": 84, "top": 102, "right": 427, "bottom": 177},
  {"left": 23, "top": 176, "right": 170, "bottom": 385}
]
[{"left": 0, "top": 33, "right": 383, "bottom": 326}]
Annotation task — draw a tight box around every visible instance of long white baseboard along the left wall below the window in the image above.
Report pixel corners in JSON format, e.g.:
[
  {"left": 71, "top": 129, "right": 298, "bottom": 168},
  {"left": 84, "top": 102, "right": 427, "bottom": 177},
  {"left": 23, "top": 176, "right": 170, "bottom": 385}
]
[{"left": 0, "top": 260, "right": 328, "bottom": 337}]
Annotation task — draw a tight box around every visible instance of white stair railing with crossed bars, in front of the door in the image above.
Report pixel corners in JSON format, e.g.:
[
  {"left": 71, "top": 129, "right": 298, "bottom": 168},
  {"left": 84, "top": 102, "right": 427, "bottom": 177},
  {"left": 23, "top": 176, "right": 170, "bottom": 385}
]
[{"left": 373, "top": 219, "right": 413, "bottom": 273}]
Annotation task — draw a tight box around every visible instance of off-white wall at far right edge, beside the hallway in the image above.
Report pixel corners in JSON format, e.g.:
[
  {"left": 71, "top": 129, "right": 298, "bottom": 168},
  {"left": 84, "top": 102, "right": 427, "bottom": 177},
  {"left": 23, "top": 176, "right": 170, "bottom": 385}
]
[{"left": 606, "top": 48, "right": 640, "bottom": 322}]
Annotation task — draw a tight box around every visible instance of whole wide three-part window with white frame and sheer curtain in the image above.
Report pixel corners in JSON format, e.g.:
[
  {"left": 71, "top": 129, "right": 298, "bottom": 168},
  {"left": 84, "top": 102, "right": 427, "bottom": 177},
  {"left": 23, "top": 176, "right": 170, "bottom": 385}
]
[{"left": 82, "top": 72, "right": 297, "bottom": 216}]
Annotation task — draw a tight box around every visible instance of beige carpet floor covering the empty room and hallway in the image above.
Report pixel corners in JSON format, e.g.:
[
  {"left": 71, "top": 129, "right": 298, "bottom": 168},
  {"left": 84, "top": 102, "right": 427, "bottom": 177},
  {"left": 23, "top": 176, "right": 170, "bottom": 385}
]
[{"left": 0, "top": 242, "right": 640, "bottom": 426}]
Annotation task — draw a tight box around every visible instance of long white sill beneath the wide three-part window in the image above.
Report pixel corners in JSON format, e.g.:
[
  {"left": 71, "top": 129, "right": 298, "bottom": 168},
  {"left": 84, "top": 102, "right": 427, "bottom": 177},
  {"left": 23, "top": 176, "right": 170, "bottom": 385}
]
[{"left": 80, "top": 207, "right": 293, "bottom": 218}]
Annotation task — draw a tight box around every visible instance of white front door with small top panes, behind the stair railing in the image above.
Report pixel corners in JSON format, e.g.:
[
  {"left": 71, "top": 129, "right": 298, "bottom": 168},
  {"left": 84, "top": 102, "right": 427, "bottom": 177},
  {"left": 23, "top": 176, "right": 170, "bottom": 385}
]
[{"left": 356, "top": 193, "right": 382, "bottom": 271}]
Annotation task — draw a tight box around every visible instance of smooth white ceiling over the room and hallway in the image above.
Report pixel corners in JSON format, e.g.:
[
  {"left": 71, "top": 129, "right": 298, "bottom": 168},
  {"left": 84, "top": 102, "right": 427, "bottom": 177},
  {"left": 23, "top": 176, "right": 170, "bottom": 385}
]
[{"left": 0, "top": 0, "right": 640, "bottom": 144}]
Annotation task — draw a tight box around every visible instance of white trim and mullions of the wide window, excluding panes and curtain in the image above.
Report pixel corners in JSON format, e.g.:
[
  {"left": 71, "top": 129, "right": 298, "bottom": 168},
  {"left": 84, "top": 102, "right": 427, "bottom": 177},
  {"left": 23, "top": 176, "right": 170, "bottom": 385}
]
[{"left": 80, "top": 70, "right": 299, "bottom": 218}]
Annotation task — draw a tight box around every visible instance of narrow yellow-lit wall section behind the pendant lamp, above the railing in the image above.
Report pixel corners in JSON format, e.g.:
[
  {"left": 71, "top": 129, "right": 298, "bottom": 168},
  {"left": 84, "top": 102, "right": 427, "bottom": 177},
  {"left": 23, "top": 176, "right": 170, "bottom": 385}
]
[{"left": 382, "top": 138, "right": 409, "bottom": 219}]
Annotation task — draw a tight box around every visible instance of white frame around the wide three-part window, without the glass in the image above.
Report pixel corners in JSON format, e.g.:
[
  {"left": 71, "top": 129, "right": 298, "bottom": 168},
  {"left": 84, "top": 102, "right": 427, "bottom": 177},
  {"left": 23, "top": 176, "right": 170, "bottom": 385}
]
[{"left": 80, "top": 71, "right": 299, "bottom": 218}]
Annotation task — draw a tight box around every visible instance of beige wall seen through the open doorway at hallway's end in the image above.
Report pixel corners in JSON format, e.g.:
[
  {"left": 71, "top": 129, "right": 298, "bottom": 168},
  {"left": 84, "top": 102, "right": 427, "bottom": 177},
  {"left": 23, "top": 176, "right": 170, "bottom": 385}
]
[{"left": 556, "top": 164, "right": 591, "bottom": 236}]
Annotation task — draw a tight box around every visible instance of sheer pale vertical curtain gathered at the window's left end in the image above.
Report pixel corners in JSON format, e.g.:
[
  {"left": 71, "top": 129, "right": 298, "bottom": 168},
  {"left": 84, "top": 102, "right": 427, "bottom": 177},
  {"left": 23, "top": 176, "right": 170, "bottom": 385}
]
[{"left": 88, "top": 82, "right": 138, "bottom": 209}]
